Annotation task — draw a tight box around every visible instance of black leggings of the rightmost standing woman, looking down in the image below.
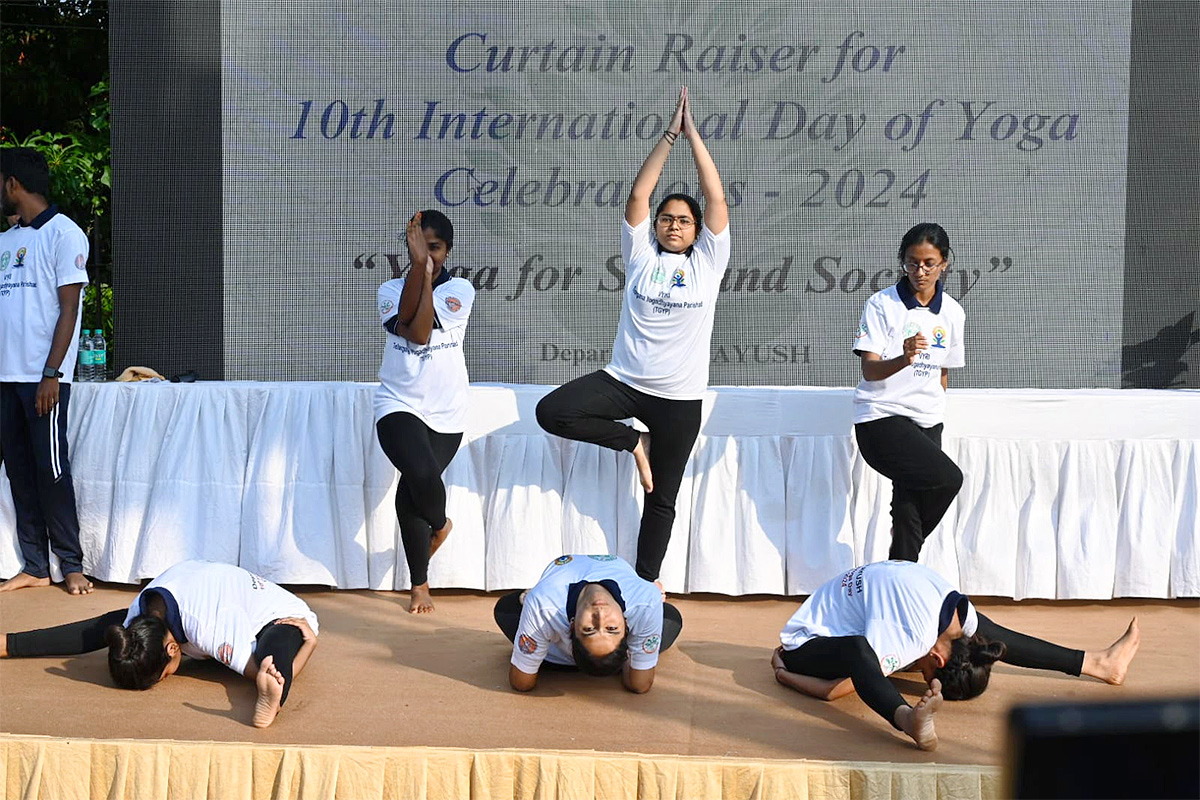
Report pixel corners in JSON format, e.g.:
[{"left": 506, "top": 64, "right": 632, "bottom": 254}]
[{"left": 854, "top": 416, "right": 962, "bottom": 561}]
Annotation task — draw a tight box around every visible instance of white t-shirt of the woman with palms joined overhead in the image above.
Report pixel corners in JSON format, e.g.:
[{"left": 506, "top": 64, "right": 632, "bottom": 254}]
[{"left": 605, "top": 217, "right": 730, "bottom": 399}]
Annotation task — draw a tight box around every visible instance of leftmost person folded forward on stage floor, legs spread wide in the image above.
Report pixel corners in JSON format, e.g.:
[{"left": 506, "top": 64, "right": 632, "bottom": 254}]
[{"left": 0, "top": 561, "right": 318, "bottom": 728}]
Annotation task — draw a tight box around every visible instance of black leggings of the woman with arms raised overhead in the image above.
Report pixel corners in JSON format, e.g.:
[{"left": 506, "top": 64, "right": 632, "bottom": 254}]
[{"left": 538, "top": 369, "right": 701, "bottom": 581}]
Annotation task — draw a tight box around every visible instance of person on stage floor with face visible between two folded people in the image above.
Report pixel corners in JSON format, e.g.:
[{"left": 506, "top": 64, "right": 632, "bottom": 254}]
[{"left": 494, "top": 555, "right": 683, "bottom": 693}]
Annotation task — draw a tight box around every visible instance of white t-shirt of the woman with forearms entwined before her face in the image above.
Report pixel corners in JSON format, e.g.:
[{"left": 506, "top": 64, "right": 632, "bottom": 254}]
[{"left": 374, "top": 271, "right": 475, "bottom": 433}]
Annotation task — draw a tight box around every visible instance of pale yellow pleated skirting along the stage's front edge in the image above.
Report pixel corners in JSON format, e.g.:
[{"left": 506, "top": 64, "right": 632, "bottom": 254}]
[{"left": 0, "top": 734, "right": 1001, "bottom": 800}]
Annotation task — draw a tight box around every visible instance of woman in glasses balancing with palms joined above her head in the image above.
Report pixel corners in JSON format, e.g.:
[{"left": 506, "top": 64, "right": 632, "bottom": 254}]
[{"left": 538, "top": 88, "right": 730, "bottom": 582}]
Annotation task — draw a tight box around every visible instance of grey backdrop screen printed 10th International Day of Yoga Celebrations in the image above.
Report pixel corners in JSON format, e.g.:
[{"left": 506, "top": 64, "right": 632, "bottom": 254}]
[{"left": 222, "top": 0, "right": 1130, "bottom": 387}]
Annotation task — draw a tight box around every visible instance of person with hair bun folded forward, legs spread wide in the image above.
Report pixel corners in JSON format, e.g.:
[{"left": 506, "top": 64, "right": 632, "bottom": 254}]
[{"left": 772, "top": 560, "right": 1141, "bottom": 750}]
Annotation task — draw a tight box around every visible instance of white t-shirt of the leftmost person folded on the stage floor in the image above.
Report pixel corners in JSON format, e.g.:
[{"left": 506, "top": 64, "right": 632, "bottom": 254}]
[{"left": 125, "top": 561, "right": 318, "bottom": 674}]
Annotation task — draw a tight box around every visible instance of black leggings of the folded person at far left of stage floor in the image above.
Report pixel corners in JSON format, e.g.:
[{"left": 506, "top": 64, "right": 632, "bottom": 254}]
[{"left": 8, "top": 608, "right": 304, "bottom": 705}]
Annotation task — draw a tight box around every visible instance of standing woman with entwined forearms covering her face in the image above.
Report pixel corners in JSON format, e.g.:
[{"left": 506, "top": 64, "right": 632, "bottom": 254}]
[{"left": 374, "top": 210, "right": 475, "bottom": 614}]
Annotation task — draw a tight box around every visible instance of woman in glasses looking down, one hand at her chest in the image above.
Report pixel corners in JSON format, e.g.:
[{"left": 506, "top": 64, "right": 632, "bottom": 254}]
[{"left": 854, "top": 222, "right": 966, "bottom": 561}]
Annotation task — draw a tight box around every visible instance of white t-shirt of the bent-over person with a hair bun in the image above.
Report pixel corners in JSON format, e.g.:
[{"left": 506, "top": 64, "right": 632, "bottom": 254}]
[{"left": 779, "top": 561, "right": 979, "bottom": 675}]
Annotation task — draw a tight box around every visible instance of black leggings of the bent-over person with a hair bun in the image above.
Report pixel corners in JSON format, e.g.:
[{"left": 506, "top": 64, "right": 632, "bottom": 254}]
[{"left": 782, "top": 612, "right": 1084, "bottom": 727}]
